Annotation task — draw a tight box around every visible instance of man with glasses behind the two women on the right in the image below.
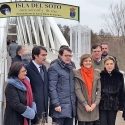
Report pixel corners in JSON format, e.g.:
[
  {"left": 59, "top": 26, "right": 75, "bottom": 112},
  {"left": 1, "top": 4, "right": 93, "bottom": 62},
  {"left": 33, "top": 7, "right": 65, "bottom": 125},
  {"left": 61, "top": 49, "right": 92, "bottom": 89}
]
[{"left": 91, "top": 44, "right": 104, "bottom": 70}]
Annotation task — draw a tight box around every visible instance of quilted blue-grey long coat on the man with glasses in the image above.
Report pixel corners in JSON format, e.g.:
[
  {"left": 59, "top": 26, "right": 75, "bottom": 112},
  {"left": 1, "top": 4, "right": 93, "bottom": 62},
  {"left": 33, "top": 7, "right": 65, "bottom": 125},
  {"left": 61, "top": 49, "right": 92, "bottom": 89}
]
[{"left": 48, "top": 60, "right": 76, "bottom": 118}]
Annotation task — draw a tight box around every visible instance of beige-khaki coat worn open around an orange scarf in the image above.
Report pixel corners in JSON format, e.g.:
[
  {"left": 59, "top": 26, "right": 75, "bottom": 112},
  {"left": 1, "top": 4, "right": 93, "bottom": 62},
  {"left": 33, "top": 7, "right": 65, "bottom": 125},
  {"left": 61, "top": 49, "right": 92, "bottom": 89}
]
[{"left": 74, "top": 70, "right": 101, "bottom": 121}]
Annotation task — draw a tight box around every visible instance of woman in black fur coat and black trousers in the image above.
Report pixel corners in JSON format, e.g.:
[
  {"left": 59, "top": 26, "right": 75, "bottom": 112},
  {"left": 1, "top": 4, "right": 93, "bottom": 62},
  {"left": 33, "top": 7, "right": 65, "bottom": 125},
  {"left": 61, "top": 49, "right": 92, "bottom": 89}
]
[{"left": 100, "top": 56, "right": 124, "bottom": 125}]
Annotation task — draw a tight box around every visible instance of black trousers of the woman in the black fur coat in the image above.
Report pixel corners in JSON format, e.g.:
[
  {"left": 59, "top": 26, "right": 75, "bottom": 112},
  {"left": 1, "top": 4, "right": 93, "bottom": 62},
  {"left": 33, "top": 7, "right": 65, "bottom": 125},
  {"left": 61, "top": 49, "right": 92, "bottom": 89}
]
[{"left": 99, "top": 110, "right": 117, "bottom": 125}]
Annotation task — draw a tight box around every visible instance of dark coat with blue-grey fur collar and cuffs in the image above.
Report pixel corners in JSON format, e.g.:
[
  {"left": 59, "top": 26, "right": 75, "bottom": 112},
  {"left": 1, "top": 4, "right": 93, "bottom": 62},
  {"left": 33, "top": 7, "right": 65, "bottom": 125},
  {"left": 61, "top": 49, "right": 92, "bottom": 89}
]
[{"left": 4, "top": 78, "right": 36, "bottom": 125}]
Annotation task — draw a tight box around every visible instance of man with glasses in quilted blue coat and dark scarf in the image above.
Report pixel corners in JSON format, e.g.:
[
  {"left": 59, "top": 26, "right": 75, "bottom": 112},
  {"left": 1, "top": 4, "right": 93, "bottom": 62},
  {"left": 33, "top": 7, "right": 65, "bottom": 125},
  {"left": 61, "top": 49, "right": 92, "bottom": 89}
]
[{"left": 48, "top": 47, "right": 76, "bottom": 125}]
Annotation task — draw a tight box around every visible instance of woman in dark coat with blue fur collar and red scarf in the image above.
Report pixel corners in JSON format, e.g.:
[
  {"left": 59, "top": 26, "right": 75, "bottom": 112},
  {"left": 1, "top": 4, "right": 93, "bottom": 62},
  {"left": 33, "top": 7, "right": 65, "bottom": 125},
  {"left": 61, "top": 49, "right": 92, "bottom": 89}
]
[{"left": 4, "top": 62, "right": 36, "bottom": 125}]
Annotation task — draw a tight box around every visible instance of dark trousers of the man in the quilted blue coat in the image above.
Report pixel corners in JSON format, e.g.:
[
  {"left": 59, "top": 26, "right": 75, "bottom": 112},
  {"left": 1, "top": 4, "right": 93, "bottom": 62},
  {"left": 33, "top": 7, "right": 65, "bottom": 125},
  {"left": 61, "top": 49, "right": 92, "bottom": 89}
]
[{"left": 53, "top": 118, "right": 73, "bottom": 125}]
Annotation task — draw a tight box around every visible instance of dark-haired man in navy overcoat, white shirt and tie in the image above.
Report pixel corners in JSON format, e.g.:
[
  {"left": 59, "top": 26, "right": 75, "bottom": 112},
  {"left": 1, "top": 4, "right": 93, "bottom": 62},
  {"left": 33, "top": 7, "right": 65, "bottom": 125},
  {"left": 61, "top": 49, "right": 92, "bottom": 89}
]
[{"left": 26, "top": 46, "right": 48, "bottom": 125}]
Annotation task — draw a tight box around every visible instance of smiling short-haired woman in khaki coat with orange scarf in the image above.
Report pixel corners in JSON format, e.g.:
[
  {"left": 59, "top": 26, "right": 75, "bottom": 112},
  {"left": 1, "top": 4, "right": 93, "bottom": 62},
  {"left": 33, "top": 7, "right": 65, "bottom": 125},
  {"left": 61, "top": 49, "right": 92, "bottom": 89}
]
[{"left": 74, "top": 54, "right": 101, "bottom": 125}]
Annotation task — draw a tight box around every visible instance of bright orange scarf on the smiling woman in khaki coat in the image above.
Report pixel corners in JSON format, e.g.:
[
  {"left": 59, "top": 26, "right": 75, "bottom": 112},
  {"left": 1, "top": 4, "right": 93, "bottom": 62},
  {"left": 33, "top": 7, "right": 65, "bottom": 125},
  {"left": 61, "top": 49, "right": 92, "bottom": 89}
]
[{"left": 80, "top": 66, "right": 94, "bottom": 104}]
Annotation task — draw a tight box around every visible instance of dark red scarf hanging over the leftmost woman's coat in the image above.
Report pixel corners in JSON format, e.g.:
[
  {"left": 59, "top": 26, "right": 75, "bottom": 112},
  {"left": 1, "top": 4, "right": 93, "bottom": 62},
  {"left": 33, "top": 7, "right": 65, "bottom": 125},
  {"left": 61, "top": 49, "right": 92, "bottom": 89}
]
[{"left": 21, "top": 79, "right": 33, "bottom": 125}]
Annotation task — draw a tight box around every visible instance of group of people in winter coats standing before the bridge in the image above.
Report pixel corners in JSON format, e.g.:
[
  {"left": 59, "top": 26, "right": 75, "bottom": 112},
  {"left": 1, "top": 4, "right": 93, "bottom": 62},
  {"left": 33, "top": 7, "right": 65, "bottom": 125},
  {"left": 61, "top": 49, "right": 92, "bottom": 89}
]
[{"left": 4, "top": 43, "right": 125, "bottom": 125}]
